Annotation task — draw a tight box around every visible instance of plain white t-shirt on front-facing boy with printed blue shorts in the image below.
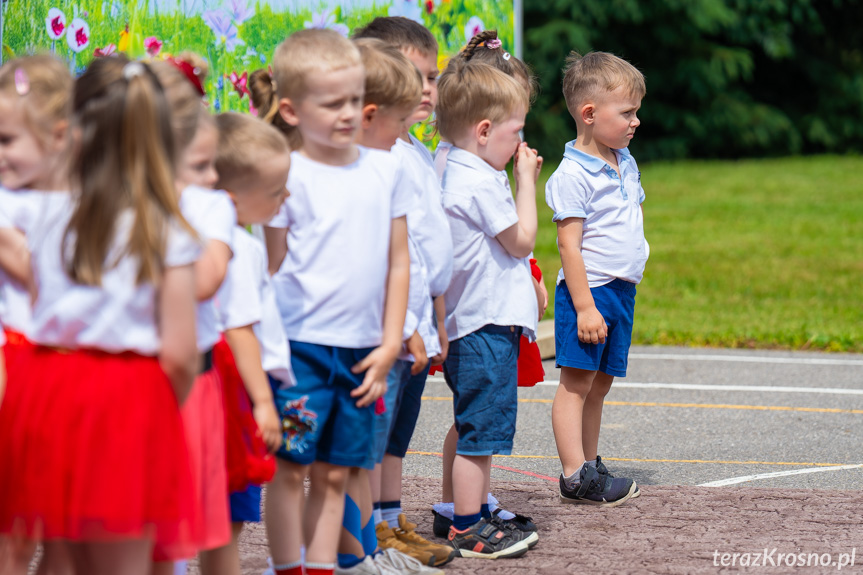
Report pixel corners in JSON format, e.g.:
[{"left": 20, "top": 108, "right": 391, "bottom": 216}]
[{"left": 269, "top": 147, "right": 413, "bottom": 348}]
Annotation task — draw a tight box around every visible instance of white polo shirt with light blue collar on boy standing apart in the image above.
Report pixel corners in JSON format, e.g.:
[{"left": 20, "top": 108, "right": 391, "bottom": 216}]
[{"left": 545, "top": 140, "right": 650, "bottom": 287}]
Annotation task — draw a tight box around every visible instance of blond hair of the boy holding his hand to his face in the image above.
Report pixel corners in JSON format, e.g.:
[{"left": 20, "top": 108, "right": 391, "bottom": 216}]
[{"left": 437, "top": 58, "right": 529, "bottom": 142}]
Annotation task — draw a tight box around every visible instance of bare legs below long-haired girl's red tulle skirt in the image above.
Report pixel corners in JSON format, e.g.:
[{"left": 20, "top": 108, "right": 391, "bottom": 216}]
[{"left": 69, "top": 539, "right": 153, "bottom": 575}]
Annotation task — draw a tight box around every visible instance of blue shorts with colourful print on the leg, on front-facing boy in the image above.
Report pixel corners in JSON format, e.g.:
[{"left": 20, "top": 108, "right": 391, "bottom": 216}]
[{"left": 271, "top": 341, "right": 375, "bottom": 467}]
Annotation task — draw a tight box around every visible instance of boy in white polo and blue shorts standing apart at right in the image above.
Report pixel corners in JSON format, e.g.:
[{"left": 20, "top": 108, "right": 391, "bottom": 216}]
[{"left": 545, "top": 52, "right": 649, "bottom": 507}]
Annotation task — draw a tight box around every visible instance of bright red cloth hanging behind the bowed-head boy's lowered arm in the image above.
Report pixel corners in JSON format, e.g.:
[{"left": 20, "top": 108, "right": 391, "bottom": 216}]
[{"left": 213, "top": 339, "right": 276, "bottom": 493}]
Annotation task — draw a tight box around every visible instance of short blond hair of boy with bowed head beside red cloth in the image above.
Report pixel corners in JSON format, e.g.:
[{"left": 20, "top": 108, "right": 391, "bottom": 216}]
[{"left": 216, "top": 112, "right": 291, "bottom": 193}]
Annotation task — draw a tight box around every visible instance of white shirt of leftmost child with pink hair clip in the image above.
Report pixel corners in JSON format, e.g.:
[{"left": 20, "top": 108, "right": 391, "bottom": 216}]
[{"left": 0, "top": 188, "right": 64, "bottom": 333}]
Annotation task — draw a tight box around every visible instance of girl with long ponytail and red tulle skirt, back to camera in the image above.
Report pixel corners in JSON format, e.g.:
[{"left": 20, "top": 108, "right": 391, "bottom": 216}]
[{"left": 0, "top": 57, "right": 200, "bottom": 575}]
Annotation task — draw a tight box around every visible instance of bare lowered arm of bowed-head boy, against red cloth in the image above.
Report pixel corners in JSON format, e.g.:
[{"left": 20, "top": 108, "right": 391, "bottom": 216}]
[{"left": 225, "top": 325, "right": 282, "bottom": 452}]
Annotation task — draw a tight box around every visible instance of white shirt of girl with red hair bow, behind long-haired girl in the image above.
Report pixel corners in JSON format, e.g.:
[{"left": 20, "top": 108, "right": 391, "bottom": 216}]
[{"left": 180, "top": 186, "right": 237, "bottom": 352}]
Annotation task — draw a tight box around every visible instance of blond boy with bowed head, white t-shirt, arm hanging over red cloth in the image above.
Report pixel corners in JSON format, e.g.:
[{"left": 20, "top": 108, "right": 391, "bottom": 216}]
[{"left": 211, "top": 113, "right": 294, "bottom": 575}]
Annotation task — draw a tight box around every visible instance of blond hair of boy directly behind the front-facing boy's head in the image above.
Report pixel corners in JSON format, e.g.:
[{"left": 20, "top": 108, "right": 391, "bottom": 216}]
[{"left": 354, "top": 38, "right": 423, "bottom": 110}]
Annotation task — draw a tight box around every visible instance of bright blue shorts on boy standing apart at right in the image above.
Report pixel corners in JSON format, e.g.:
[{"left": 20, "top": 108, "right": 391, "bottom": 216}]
[{"left": 554, "top": 279, "right": 635, "bottom": 377}]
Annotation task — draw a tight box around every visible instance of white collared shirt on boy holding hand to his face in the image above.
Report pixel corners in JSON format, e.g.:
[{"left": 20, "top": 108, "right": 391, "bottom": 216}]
[{"left": 442, "top": 147, "right": 539, "bottom": 341}]
